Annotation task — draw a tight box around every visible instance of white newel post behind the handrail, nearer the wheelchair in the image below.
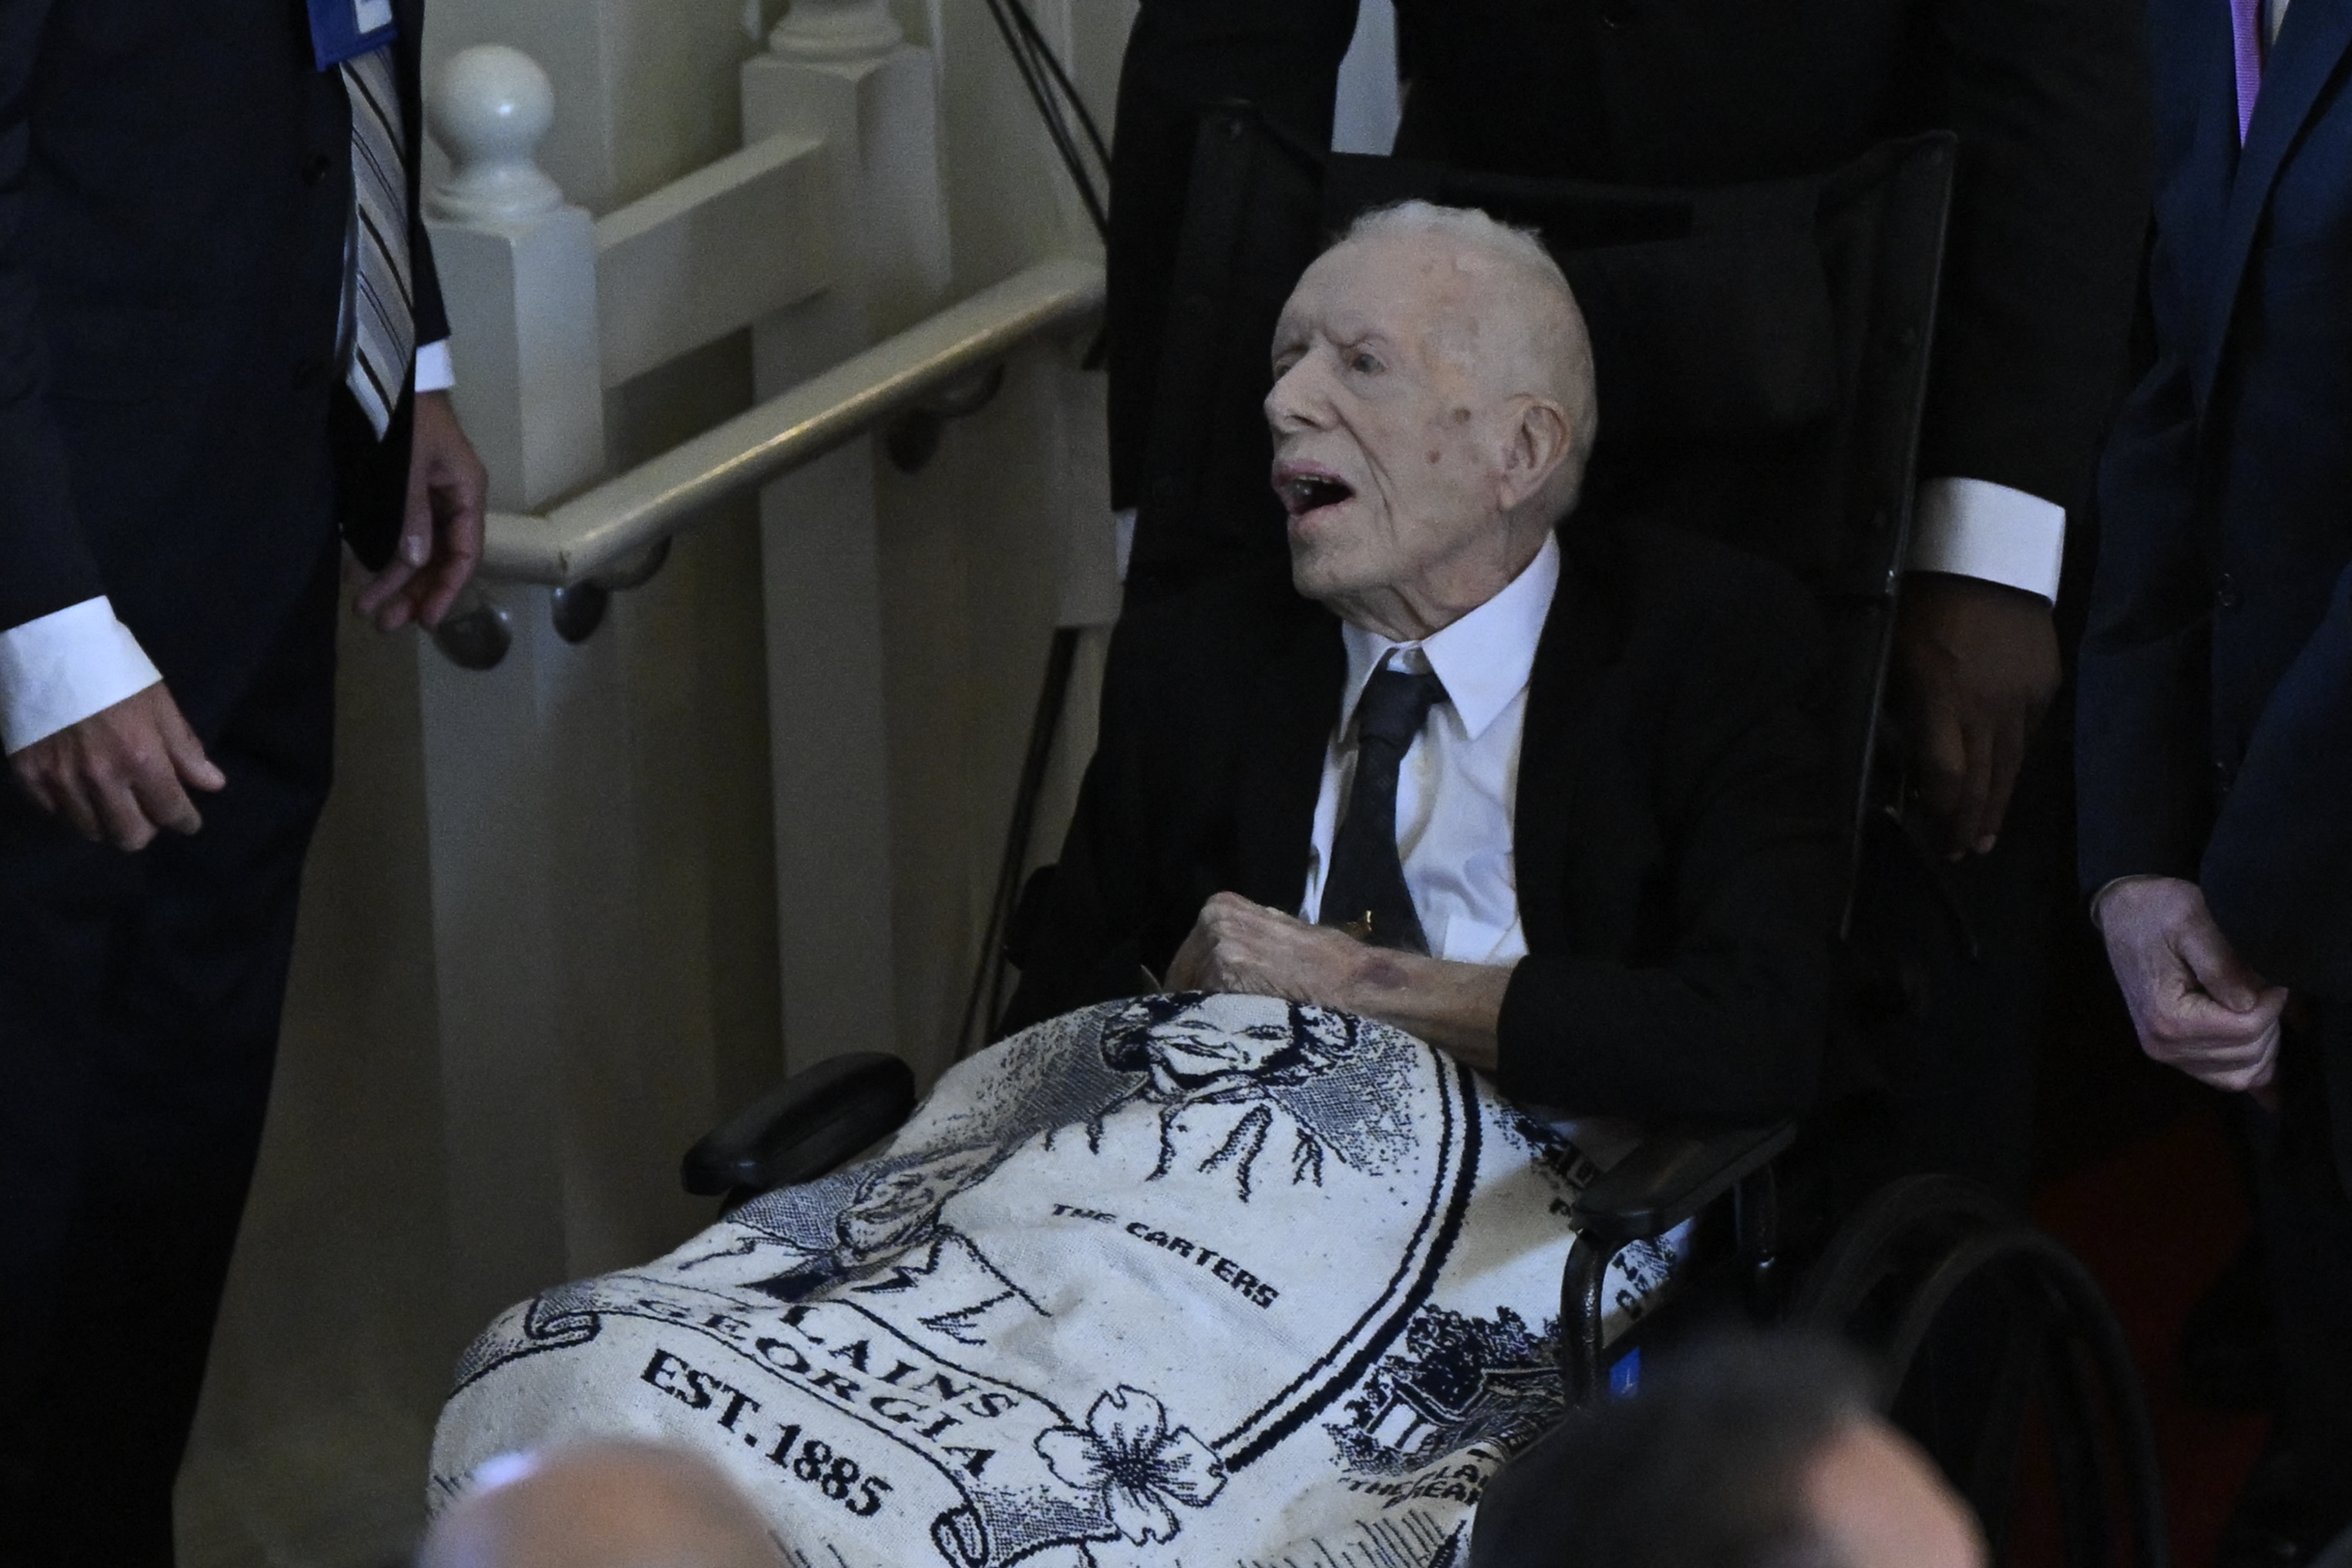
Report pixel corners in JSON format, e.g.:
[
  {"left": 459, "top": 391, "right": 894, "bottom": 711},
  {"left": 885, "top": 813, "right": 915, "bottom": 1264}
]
[{"left": 743, "top": 0, "right": 948, "bottom": 1070}]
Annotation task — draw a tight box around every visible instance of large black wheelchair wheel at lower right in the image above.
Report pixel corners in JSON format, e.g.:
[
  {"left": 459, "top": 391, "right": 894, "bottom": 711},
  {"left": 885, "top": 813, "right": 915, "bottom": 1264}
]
[{"left": 1788, "top": 1175, "right": 2171, "bottom": 1568}]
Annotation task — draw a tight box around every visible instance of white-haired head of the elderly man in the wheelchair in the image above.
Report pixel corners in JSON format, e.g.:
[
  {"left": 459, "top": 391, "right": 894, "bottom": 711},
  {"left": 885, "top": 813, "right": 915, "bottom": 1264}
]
[{"left": 1265, "top": 203, "right": 1597, "bottom": 642}]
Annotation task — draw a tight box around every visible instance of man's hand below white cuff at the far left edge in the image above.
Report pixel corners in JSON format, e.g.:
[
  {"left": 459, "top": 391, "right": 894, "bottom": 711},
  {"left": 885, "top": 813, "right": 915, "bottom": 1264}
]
[{"left": 10, "top": 682, "right": 228, "bottom": 851}]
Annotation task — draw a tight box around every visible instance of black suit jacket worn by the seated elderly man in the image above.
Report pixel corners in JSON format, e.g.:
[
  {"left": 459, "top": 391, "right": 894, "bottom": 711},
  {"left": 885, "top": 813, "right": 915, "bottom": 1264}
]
[{"left": 1007, "top": 517, "right": 1837, "bottom": 1119}]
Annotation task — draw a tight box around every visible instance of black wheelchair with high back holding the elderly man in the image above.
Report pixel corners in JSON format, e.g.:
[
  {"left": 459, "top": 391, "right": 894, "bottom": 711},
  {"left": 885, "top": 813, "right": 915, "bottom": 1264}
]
[{"left": 684, "top": 104, "right": 2168, "bottom": 1568}]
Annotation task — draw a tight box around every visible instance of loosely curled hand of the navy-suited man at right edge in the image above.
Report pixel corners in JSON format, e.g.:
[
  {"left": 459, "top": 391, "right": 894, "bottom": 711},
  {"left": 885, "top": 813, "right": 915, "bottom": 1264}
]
[{"left": 2098, "top": 877, "right": 2286, "bottom": 1094}]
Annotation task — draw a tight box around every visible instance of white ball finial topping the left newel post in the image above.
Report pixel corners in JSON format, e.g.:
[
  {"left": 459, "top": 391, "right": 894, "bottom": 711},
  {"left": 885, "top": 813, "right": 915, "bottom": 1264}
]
[{"left": 425, "top": 45, "right": 564, "bottom": 223}]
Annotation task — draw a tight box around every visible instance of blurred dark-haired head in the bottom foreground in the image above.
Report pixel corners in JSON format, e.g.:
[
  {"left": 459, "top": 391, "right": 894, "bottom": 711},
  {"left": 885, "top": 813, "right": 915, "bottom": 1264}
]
[{"left": 1470, "top": 1335, "right": 1985, "bottom": 1568}]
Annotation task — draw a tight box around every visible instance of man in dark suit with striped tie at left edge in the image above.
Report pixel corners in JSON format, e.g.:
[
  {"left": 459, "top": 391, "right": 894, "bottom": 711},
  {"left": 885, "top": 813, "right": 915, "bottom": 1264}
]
[{"left": 0, "top": 0, "right": 482, "bottom": 1566}]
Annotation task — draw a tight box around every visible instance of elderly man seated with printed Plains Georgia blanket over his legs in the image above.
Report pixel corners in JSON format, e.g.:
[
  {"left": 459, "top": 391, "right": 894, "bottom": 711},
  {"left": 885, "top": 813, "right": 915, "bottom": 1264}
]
[{"left": 435, "top": 203, "right": 1839, "bottom": 1568}]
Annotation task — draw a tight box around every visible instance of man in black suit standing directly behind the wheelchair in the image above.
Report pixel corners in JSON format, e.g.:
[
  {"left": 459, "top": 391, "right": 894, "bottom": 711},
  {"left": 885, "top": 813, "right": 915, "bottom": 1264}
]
[{"left": 1110, "top": 0, "right": 2145, "bottom": 1196}]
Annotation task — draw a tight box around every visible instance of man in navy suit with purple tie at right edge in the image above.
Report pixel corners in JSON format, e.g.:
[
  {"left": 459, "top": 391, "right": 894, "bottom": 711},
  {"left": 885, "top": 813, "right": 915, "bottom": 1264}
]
[{"left": 2077, "top": 0, "right": 2352, "bottom": 1563}]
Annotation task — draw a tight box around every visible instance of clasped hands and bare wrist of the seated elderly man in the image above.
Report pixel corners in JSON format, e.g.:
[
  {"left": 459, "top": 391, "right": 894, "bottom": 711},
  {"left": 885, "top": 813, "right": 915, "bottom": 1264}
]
[{"left": 1166, "top": 893, "right": 1510, "bottom": 1072}]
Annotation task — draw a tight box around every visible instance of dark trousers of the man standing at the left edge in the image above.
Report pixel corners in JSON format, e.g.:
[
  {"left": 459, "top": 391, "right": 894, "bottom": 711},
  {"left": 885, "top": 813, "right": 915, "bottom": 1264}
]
[{"left": 0, "top": 550, "right": 336, "bottom": 1568}]
